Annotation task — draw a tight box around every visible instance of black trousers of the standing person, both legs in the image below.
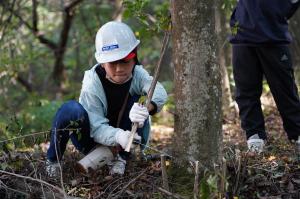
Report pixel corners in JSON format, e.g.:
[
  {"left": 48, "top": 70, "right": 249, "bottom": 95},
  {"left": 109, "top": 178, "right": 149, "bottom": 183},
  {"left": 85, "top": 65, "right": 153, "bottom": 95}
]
[{"left": 232, "top": 46, "right": 300, "bottom": 140}]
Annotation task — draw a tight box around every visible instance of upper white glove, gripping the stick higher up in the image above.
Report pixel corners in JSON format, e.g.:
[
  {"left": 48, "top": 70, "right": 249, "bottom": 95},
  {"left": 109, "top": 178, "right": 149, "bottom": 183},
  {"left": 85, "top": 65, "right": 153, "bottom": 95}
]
[{"left": 129, "top": 103, "right": 149, "bottom": 128}]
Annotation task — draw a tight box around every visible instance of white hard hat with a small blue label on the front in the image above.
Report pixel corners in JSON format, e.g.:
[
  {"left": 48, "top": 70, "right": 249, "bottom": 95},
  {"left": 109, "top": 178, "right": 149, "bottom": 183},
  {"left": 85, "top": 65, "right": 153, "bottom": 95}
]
[{"left": 95, "top": 21, "right": 140, "bottom": 64}]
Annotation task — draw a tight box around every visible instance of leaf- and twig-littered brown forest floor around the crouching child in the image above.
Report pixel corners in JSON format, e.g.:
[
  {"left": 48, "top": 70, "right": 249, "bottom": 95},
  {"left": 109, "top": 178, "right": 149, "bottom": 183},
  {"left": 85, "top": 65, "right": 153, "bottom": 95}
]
[{"left": 0, "top": 93, "right": 300, "bottom": 199}]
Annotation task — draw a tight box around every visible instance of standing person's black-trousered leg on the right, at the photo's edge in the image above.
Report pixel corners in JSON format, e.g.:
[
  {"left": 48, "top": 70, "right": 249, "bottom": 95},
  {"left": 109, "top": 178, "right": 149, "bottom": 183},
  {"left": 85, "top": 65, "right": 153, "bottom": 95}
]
[{"left": 259, "top": 46, "right": 300, "bottom": 140}]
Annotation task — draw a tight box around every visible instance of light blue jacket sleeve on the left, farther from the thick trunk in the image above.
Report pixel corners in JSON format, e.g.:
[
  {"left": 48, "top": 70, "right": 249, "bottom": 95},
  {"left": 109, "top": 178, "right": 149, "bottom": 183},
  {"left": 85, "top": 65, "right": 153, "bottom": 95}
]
[{"left": 79, "top": 80, "right": 120, "bottom": 146}]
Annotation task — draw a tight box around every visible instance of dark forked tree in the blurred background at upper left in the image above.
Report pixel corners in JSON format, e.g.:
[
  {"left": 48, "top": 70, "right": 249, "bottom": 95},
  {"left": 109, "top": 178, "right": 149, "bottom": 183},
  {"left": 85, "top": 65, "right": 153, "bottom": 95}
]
[{"left": 1, "top": 0, "right": 82, "bottom": 92}]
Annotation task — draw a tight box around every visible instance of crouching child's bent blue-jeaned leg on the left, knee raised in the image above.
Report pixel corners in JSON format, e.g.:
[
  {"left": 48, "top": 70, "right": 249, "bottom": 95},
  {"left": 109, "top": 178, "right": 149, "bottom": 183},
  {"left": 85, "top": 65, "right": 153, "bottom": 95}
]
[{"left": 47, "top": 100, "right": 95, "bottom": 162}]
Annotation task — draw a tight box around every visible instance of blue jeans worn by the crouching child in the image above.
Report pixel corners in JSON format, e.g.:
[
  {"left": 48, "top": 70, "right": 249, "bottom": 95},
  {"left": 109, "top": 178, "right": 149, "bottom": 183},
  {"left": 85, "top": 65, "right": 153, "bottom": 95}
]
[{"left": 47, "top": 96, "right": 150, "bottom": 162}]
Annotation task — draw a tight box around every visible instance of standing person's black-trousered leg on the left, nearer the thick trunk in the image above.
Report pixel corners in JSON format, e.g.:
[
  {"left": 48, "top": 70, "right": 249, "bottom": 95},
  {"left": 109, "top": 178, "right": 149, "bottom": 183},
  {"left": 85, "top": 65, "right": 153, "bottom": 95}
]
[{"left": 232, "top": 46, "right": 267, "bottom": 139}]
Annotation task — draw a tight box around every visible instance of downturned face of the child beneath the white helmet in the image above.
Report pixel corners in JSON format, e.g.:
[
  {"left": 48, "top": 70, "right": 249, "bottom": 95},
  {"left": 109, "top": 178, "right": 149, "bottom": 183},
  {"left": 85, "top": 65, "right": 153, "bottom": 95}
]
[{"left": 102, "top": 59, "right": 135, "bottom": 84}]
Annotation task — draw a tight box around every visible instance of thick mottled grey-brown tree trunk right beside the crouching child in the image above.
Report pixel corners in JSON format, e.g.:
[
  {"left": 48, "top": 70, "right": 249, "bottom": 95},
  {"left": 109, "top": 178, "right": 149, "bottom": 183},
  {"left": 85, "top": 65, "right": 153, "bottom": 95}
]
[{"left": 172, "top": 0, "right": 222, "bottom": 169}]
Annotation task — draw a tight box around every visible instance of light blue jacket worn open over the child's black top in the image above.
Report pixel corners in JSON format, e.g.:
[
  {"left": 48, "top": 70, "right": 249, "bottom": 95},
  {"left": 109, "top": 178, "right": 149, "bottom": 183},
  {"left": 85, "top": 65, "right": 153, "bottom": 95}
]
[{"left": 79, "top": 65, "right": 167, "bottom": 146}]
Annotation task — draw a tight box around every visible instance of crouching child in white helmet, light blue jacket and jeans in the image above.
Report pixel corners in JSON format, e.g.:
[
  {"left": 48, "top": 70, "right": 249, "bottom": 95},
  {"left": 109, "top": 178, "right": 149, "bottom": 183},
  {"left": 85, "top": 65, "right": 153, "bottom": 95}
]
[{"left": 46, "top": 21, "right": 167, "bottom": 176}]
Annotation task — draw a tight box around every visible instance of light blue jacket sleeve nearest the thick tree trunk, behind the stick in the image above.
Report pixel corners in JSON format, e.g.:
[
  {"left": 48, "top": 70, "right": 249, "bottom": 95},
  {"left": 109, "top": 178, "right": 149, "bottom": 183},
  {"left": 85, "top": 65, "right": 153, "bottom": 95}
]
[{"left": 134, "top": 66, "right": 168, "bottom": 112}]
